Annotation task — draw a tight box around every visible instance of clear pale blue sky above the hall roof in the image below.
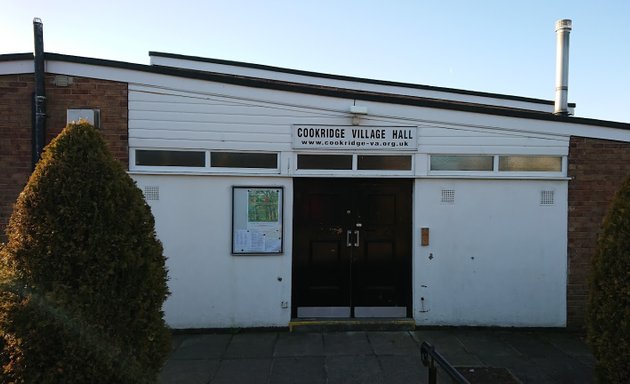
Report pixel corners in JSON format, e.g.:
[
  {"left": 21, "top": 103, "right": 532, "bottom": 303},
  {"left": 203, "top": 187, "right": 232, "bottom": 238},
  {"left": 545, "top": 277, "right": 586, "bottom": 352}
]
[{"left": 0, "top": 0, "right": 630, "bottom": 123}]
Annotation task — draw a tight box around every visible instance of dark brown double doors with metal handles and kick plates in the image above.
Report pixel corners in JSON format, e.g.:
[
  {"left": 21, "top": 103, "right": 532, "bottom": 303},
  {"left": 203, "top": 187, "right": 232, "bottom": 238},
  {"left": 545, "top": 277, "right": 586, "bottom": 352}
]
[{"left": 292, "top": 178, "right": 412, "bottom": 317}]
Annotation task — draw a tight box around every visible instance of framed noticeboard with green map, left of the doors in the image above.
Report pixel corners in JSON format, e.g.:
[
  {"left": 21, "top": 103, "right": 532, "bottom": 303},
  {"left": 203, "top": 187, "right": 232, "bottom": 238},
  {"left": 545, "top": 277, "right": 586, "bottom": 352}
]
[{"left": 232, "top": 187, "right": 284, "bottom": 255}]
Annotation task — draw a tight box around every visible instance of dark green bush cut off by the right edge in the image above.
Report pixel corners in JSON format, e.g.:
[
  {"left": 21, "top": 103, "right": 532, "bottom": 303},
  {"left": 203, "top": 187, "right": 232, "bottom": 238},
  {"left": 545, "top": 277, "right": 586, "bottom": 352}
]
[{"left": 588, "top": 178, "right": 630, "bottom": 384}]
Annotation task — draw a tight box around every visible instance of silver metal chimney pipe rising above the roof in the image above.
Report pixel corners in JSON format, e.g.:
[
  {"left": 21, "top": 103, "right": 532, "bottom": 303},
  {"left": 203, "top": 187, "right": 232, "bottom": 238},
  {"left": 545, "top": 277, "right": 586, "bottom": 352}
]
[{"left": 553, "top": 19, "right": 571, "bottom": 116}]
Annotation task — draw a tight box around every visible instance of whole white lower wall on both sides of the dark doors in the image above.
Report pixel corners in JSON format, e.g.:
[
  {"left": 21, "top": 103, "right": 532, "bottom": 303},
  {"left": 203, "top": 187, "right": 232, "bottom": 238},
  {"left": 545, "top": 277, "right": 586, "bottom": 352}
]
[{"left": 133, "top": 174, "right": 567, "bottom": 328}]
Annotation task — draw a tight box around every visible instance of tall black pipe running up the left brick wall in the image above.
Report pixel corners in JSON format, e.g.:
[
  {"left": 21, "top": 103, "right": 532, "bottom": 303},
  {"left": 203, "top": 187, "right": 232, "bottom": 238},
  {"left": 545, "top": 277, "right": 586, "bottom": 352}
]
[{"left": 32, "top": 18, "right": 46, "bottom": 168}]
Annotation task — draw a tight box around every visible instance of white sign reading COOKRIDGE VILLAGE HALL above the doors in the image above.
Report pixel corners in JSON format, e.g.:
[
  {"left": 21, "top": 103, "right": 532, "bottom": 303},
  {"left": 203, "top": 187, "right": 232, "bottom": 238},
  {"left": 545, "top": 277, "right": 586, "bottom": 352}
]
[{"left": 292, "top": 125, "right": 418, "bottom": 151}]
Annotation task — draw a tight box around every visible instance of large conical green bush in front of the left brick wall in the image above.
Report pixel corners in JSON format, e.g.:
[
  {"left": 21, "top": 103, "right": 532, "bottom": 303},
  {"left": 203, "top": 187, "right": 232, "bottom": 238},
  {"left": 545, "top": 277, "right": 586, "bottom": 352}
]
[{"left": 0, "top": 122, "right": 171, "bottom": 383}]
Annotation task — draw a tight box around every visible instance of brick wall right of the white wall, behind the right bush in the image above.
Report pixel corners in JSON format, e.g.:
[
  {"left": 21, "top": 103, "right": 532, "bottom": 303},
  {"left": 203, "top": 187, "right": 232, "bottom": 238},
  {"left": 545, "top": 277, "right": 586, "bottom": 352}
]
[{"left": 567, "top": 137, "right": 630, "bottom": 328}]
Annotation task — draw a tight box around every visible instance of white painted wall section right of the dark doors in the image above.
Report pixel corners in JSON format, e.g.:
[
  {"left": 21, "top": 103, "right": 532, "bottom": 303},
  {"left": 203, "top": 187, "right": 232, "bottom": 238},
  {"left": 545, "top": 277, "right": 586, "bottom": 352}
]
[{"left": 413, "top": 179, "right": 567, "bottom": 327}]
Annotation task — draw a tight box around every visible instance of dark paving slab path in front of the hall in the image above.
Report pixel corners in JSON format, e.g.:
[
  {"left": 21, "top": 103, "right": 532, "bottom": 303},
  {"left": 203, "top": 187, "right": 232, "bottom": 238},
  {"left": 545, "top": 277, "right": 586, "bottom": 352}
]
[{"left": 160, "top": 328, "right": 594, "bottom": 384}]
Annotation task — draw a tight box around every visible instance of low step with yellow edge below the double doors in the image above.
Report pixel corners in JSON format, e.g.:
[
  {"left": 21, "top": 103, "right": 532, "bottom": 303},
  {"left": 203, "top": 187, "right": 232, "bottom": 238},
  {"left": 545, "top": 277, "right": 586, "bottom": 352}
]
[{"left": 289, "top": 318, "right": 416, "bottom": 332}]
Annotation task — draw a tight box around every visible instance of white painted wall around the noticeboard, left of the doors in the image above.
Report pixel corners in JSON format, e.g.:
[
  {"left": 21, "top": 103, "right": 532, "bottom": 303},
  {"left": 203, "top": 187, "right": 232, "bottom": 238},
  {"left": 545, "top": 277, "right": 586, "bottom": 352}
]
[{"left": 132, "top": 175, "right": 293, "bottom": 328}]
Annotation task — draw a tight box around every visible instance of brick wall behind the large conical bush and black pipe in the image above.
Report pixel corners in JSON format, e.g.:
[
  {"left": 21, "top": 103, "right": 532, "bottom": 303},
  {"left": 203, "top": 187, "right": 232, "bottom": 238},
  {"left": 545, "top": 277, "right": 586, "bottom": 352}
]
[{"left": 0, "top": 74, "right": 128, "bottom": 242}]
